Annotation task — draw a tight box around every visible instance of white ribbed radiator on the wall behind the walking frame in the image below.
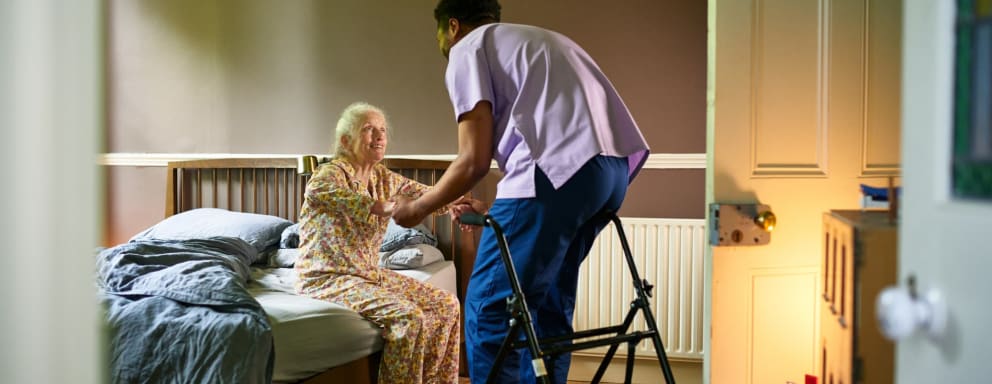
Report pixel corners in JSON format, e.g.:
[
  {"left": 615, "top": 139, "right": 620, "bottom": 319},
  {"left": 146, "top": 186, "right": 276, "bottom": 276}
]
[{"left": 573, "top": 218, "right": 706, "bottom": 361}]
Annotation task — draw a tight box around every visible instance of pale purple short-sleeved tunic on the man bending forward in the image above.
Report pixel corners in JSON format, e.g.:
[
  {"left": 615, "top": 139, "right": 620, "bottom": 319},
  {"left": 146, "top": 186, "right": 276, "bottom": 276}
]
[{"left": 445, "top": 23, "right": 649, "bottom": 198}]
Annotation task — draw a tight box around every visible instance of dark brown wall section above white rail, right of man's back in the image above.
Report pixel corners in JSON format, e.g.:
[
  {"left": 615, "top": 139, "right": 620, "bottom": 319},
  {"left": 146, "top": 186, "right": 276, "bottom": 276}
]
[{"left": 501, "top": 0, "right": 706, "bottom": 153}]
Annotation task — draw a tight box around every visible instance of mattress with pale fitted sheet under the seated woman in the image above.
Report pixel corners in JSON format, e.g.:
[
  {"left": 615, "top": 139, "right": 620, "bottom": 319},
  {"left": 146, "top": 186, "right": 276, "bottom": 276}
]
[{"left": 248, "top": 261, "right": 457, "bottom": 383}]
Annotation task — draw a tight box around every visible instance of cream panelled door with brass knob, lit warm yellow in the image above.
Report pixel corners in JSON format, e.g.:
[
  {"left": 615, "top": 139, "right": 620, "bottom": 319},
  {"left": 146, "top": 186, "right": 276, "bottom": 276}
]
[{"left": 704, "top": 0, "right": 901, "bottom": 384}]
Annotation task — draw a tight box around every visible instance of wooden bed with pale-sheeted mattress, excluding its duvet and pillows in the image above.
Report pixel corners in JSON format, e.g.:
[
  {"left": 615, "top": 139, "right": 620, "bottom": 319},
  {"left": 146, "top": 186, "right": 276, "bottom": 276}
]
[{"left": 98, "top": 157, "right": 498, "bottom": 384}]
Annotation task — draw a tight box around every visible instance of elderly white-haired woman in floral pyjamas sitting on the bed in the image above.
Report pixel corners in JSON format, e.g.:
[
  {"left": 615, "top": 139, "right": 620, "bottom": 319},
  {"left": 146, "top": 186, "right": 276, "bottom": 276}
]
[{"left": 295, "top": 103, "right": 460, "bottom": 383}]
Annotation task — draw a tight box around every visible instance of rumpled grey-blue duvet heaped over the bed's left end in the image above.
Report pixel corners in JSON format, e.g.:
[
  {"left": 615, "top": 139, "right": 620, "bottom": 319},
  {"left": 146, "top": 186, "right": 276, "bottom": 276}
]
[{"left": 97, "top": 237, "right": 274, "bottom": 383}]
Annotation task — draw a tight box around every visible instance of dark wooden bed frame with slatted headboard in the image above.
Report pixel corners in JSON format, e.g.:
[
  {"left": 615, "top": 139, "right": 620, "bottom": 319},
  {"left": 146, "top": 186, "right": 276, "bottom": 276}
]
[{"left": 165, "top": 156, "right": 499, "bottom": 384}]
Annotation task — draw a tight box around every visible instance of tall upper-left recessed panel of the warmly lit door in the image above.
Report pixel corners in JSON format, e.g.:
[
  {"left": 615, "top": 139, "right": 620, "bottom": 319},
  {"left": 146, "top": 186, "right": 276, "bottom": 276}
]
[{"left": 749, "top": 0, "right": 826, "bottom": 175}]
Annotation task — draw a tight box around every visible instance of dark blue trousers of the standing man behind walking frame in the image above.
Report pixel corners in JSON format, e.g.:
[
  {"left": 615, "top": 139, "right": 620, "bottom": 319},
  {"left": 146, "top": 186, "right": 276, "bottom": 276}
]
[{"left": 465, "top": 156, "right": 628, "bottom": 383}]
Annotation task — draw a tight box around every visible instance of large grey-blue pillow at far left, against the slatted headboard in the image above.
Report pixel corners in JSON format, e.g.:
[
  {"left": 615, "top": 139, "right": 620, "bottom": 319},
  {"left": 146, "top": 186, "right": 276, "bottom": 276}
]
[{"left": 131, "top": 208, "right": 293, "bottom": 254}]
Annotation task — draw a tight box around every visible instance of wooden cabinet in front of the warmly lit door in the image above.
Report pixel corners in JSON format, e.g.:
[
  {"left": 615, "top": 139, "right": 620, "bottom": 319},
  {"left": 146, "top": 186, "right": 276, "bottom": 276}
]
[{"left": 819, "top": 210, "right": 898, "bottom": 384}]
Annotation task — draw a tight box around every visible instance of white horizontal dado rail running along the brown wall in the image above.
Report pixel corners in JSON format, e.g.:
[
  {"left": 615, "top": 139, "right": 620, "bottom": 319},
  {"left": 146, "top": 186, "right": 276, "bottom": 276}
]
[{"left": 97, "top": 152, "right": 706, "bottom": 169}]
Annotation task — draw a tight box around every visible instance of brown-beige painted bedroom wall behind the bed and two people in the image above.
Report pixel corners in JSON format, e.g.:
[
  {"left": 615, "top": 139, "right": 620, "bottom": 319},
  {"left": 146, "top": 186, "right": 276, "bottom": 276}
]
[{"left": 107, "top": 0, "right": 706, "bottom": 241}]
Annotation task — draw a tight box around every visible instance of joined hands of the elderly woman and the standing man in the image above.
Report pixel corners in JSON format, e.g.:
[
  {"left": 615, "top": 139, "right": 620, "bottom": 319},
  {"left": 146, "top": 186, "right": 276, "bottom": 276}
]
[{"left": 371, "top": 196, "right": 487, "bottom": 232}]
